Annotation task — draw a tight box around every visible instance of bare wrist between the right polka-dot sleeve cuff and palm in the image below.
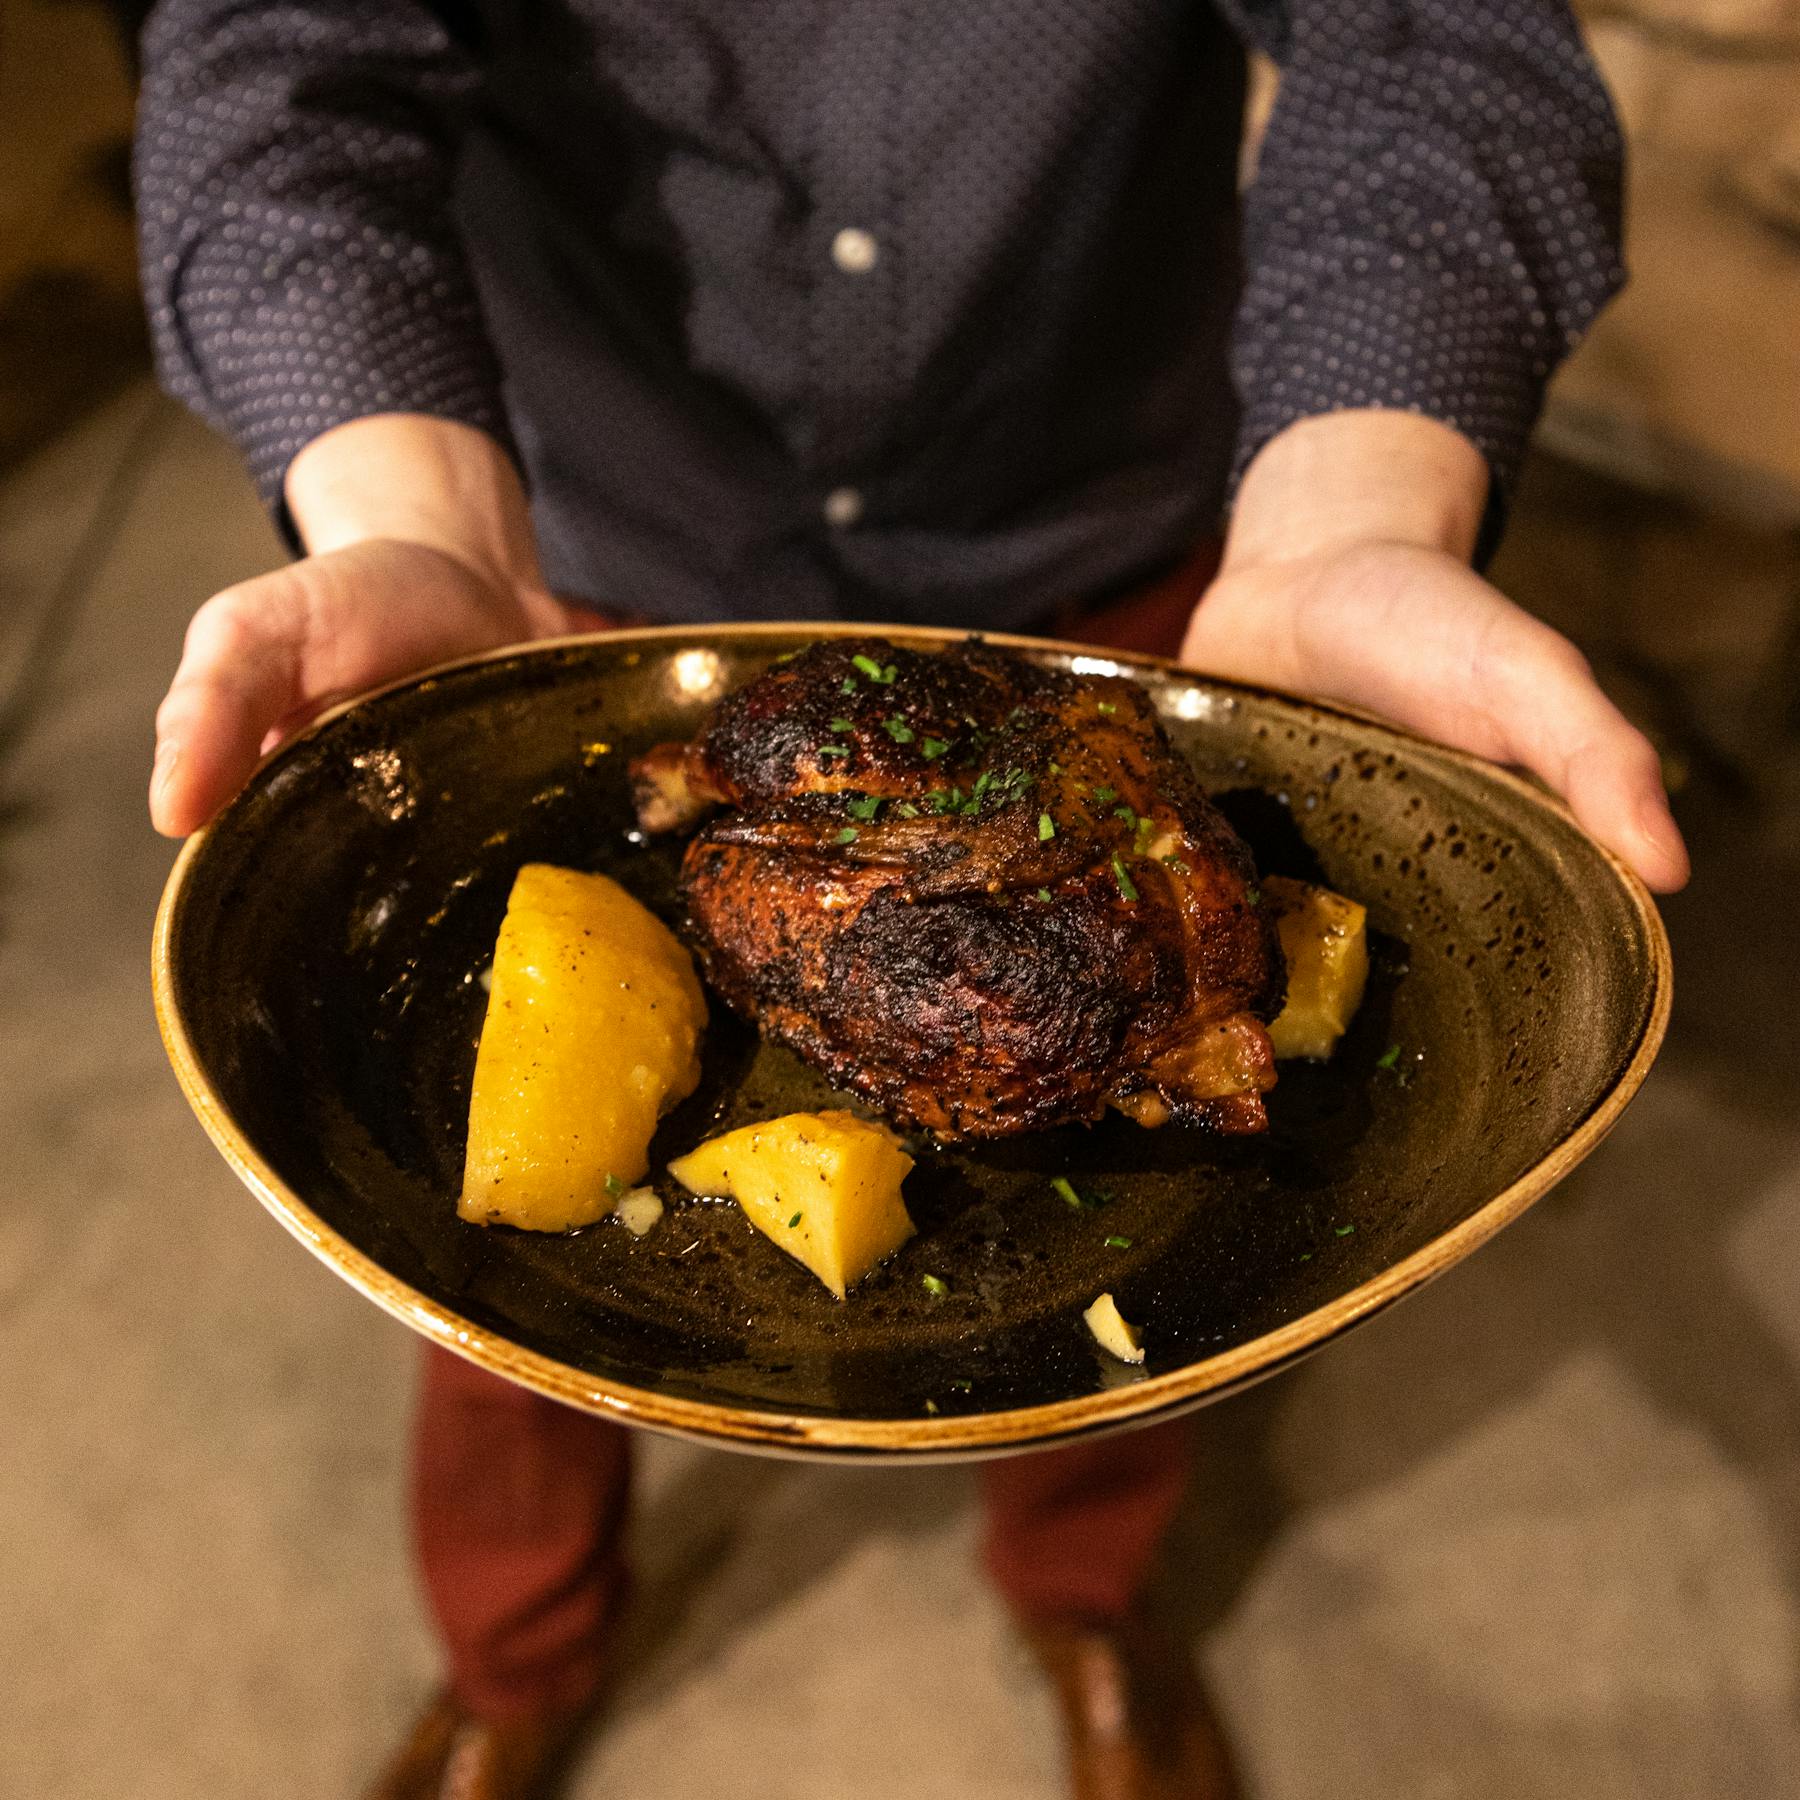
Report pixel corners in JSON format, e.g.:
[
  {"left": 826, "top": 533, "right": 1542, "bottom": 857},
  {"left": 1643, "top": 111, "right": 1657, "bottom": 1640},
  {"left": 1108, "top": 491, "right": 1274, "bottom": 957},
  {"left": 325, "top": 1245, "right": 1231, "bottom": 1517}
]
[{"left": 1224, "top": 409, "right": 1489, "bottom": 574}]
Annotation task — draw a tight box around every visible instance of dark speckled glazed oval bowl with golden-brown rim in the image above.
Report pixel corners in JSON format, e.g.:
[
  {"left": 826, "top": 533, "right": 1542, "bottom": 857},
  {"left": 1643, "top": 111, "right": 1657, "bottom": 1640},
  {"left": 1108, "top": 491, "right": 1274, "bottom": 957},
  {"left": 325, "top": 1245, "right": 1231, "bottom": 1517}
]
[{"left": 153, "top": 625, "right": 1670, "bottom": 1460}]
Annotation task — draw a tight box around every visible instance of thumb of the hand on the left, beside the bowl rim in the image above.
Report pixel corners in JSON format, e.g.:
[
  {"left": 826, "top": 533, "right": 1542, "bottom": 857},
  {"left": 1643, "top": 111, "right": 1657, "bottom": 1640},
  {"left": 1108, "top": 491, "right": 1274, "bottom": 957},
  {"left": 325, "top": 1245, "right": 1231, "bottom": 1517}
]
[{"left": 149, "top": 572, "right": 304, "bottom": 837}]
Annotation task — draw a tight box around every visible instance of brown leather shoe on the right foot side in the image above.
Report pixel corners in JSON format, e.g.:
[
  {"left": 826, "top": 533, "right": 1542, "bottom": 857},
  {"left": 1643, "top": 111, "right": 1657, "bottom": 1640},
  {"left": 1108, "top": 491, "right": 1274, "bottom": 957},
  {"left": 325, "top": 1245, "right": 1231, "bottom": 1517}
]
[{"left": 1026, "top": 1618, "right": 1242, "bottom": 1800}]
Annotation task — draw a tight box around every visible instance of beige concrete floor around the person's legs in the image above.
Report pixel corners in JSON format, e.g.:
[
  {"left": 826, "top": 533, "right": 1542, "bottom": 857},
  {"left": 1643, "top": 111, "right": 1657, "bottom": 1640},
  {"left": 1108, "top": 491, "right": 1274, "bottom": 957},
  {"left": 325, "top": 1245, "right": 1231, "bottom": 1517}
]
[{"left": 0, "top": 387, "right": 1800, "bottom": 1800}]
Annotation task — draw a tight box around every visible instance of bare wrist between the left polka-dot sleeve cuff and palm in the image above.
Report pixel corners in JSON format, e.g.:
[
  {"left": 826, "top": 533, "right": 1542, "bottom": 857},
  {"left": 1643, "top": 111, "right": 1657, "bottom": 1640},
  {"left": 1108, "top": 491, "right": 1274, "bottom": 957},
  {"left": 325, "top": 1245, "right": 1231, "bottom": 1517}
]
[{"left": 284, "top": 412, "right": 542, "bottom": 589}]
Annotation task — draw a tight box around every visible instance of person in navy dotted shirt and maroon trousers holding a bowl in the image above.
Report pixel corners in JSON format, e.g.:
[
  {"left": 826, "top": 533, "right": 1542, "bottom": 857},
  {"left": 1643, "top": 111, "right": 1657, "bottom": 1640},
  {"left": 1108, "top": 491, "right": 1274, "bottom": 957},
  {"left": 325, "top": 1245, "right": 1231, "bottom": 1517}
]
[{"left": 137, "top": 0, "right": 1687, "bottom": 1800}]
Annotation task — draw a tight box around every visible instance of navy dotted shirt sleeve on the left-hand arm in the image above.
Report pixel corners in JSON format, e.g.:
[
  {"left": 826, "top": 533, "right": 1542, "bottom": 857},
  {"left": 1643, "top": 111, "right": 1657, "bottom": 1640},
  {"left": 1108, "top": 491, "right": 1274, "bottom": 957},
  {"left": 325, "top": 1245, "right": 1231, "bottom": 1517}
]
[{"left": 137, "top": 0, "right": 508, "bottom": 517}]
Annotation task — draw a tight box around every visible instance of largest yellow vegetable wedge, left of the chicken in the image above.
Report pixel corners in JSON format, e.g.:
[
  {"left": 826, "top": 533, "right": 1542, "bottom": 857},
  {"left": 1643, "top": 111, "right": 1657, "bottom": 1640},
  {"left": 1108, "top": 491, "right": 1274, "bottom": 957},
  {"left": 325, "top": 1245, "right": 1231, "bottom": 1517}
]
[{"left": 457, "top": 862, "right": 706, "bottom": 1231}]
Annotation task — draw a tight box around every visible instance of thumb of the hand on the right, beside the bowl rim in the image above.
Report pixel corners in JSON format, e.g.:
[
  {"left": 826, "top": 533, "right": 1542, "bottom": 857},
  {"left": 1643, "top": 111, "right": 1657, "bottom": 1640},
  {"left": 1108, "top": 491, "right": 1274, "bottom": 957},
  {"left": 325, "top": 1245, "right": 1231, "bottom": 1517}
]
[{"left": 1494, "top": 632, "right": 1688, "bottom": 893}]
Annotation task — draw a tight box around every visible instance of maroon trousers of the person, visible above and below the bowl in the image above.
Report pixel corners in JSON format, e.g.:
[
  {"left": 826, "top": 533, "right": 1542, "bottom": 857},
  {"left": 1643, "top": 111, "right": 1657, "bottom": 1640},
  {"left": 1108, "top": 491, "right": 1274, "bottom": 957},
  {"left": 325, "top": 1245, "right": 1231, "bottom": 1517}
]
[{"left": 412, "top": 545, "right": 1217, "bottom": 1719}]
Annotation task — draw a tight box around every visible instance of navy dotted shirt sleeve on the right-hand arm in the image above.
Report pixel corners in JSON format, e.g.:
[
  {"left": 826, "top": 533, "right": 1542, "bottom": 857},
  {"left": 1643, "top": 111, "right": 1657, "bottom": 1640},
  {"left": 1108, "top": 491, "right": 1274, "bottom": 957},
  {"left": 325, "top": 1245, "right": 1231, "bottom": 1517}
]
[{"left": 1226, "top": 0, "right": 1624, "bottom": 502}]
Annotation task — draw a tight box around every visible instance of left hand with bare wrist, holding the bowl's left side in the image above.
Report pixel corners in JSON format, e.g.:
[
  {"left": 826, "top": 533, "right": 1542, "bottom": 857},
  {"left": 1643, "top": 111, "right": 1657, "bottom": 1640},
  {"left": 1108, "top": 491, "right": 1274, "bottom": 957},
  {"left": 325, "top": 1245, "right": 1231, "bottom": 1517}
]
[{"left": 149, "top": 414, "right": 607, "bottom": 837}]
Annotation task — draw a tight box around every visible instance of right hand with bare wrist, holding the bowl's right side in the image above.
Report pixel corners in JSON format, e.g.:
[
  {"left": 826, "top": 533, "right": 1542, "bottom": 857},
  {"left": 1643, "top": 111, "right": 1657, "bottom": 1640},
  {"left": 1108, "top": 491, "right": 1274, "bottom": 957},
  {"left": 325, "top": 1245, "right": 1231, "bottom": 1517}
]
[{"left": 1183, "top": 414, "right": 1688, "bottom": 893}]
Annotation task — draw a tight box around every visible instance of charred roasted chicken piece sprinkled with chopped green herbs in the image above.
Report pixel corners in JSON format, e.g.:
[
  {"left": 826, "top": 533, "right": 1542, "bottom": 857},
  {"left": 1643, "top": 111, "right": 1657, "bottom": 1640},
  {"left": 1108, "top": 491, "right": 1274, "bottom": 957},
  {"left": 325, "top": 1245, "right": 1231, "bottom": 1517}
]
[{"left": 632, "top": 637, "right": 1285, "bottom": 1139}]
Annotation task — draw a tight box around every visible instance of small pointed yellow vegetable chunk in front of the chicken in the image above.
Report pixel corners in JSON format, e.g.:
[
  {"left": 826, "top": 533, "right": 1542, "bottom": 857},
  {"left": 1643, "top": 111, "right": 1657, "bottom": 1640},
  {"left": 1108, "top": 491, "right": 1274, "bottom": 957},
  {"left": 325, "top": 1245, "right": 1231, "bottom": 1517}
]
[{"left": 670, "top": 1112, "right": 913, "bottom": 1300}]
